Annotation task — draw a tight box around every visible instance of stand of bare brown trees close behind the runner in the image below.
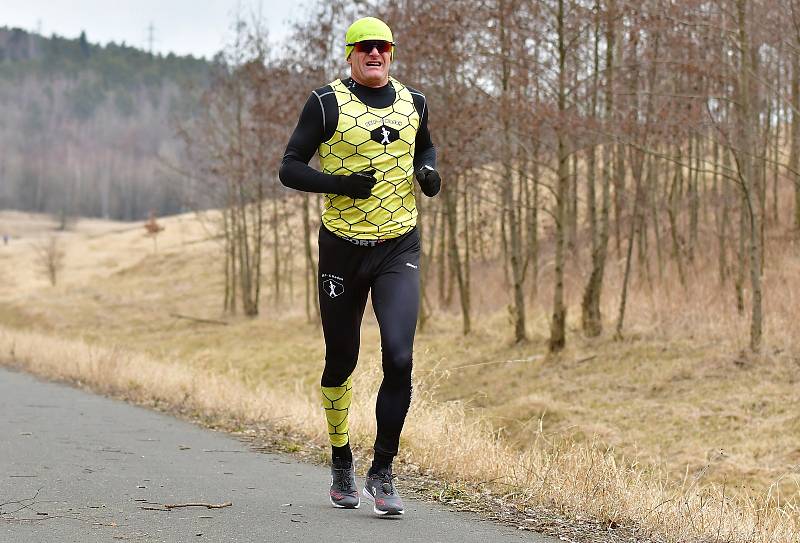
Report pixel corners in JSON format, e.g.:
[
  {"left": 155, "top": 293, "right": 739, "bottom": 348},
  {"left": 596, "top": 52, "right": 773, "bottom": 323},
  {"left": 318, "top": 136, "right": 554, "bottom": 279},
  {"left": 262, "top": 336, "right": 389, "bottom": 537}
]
[{"left": 173, "top": 0, "right": 800, "bottom": 360}]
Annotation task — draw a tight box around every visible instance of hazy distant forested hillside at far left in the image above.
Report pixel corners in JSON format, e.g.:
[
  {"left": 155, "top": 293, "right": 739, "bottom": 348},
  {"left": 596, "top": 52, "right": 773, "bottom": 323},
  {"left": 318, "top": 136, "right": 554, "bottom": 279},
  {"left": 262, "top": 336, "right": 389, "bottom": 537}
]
[{"left": 0, "top": 27, "right": 211, "bottom": 220}]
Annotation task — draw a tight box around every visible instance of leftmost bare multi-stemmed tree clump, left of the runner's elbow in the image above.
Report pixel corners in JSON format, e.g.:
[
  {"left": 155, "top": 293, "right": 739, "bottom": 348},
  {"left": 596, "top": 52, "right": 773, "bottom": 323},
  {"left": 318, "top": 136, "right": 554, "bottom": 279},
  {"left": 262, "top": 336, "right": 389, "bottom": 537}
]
[{"left": 181, "top": 20, "right": 279, "bottom": 316}]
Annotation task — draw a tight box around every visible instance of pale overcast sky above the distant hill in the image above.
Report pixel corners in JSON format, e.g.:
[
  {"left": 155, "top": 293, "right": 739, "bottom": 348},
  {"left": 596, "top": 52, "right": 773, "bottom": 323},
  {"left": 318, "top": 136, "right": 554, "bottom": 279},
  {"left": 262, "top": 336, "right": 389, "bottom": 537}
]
[{"left": 0, "top": 0, "right": 312, "bottom": 58}]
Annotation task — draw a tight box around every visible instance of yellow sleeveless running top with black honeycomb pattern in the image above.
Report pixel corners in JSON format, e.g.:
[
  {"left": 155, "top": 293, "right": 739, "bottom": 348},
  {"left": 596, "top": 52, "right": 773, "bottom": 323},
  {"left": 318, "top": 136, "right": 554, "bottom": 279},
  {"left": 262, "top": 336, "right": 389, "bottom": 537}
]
[{"left": 318, "top": 79, "right": 420, "bottom": 240}]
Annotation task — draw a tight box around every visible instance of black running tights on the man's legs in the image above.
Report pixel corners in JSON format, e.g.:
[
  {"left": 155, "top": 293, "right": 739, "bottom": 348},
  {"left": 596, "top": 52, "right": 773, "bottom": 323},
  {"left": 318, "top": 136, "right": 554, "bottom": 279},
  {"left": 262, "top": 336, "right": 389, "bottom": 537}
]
[{"left": 319, "top": 226, "right": 420, "bottom": 461}]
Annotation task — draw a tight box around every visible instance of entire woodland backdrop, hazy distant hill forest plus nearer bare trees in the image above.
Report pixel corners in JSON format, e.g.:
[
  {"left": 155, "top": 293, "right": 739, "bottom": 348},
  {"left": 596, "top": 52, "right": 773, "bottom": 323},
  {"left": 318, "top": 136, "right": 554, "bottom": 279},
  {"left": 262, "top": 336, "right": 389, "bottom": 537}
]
[{"left": 0, "top": 0, "right": 800, "bottom": 352}]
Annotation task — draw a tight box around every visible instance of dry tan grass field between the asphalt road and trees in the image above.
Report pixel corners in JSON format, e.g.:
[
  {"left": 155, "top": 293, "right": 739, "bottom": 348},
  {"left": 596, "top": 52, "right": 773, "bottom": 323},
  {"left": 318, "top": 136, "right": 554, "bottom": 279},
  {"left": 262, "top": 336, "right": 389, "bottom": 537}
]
[{"left": 0, "top": 212, "right": 800, "bottom": 543}]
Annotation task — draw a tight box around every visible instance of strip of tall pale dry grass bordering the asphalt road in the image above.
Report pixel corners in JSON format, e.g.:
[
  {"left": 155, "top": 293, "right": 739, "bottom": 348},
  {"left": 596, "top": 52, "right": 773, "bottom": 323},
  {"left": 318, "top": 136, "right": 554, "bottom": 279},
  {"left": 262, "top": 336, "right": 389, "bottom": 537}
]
[{"left": 0, "top": 329, "right": 797, "bottom": 543}]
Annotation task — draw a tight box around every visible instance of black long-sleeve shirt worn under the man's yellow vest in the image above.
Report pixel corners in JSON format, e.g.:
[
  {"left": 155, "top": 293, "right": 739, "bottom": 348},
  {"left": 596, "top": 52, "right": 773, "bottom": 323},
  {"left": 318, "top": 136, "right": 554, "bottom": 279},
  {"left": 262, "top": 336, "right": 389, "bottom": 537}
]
[{"left": 278, "top": 78, "right": 436, "bottom": 193}]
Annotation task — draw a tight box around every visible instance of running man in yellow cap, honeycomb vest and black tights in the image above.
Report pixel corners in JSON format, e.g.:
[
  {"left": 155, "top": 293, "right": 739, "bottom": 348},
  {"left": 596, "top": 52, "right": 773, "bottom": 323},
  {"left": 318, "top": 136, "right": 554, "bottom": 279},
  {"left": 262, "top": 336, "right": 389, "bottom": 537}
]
[{"left": 280, "top": 17, "right": 441, "bottom": 515}]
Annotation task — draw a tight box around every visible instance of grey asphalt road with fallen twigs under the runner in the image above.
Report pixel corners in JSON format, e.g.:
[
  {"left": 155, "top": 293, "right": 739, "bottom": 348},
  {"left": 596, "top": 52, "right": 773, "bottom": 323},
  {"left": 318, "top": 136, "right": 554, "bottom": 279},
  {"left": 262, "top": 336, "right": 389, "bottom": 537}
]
[{"left": 0, "top": 368, "right": 557, "bottom": 543}]
